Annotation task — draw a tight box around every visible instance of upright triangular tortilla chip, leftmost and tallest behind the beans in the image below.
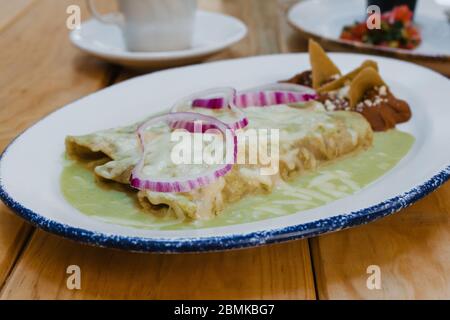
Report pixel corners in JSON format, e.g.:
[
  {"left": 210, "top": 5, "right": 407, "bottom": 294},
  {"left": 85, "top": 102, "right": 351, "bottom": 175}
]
[{"left": 308, "top": 40, "right": 341, "bottom": 89}]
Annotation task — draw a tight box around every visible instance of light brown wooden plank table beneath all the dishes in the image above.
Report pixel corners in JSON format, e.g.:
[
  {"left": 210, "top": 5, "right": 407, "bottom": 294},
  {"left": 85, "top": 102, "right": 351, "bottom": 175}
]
[{"left": 0, "top": 0, "right": 450, "bottom": 299}]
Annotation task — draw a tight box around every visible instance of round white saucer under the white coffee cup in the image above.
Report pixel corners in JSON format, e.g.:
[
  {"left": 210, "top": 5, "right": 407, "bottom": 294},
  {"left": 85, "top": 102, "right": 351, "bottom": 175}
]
[{"left": 70, "top": 10, "right": 247, "bottom": 68}]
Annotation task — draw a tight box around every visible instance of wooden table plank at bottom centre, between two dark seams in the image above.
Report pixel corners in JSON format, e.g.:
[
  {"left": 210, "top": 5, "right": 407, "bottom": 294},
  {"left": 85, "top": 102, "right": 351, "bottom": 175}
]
[{"left": 2, "top": 231, "right": 314, "bottom": 299}]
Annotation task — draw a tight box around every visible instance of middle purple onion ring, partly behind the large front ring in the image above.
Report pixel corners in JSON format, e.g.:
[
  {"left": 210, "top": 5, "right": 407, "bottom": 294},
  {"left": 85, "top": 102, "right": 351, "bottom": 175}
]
[{"left": 171, "top": 87, "right": 248, "bottom": 131}]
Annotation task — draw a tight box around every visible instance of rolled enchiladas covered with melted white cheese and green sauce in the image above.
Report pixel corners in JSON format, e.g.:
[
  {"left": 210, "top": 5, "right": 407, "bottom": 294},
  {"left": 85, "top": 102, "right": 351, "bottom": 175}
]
[{"left": 66, "top": 105, "right": 372, "bottom": 219}]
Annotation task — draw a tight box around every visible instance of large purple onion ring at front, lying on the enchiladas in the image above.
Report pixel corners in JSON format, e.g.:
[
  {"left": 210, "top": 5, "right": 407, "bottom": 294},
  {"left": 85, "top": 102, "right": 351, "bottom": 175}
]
[{"left": 130, "top": 112, "right": 238, "bottom": 192}]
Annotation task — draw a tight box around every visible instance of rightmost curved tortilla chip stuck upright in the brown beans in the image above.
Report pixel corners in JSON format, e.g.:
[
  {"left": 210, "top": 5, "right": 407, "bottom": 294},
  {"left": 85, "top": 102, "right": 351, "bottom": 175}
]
[{"left": 348, "top": 67, "right": 387, "bottom": 109}]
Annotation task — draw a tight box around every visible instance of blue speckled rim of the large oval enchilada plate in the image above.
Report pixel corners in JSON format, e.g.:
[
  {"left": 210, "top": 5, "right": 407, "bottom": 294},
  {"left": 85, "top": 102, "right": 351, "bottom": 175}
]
[{"left": 0, "top": 125, "right": 450, "bottom": 253}]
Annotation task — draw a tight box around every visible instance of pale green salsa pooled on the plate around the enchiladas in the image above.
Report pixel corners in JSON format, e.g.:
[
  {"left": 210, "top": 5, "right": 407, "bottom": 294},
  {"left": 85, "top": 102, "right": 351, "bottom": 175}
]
[{"left": 61, "top": 130, "right": 414, "bottom": 230}]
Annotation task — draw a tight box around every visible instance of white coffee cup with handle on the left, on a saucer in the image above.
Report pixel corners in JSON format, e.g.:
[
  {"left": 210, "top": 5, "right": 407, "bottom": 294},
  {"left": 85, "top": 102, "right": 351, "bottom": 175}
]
[{"left": 88, "top": 0, "right": 197, "bottom": 51}]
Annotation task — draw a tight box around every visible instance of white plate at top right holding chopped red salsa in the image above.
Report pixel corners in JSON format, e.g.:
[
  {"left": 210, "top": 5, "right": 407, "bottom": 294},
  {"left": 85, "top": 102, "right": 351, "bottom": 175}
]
[{"left": 288, "top": 0, "right": 450, "bottom": 61}]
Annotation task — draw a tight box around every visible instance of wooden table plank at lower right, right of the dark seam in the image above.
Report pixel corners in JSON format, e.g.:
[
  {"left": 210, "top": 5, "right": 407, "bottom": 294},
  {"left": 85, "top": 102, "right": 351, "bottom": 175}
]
[{"left": 311, "top": 183, "right": 450, "bottom": 299}]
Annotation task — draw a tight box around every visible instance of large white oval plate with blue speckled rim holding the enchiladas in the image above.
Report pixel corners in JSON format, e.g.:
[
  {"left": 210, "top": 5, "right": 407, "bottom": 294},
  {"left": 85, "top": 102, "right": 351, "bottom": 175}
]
[{"left": 0, "top": 54, "right": 450, "bottom": 252}]
